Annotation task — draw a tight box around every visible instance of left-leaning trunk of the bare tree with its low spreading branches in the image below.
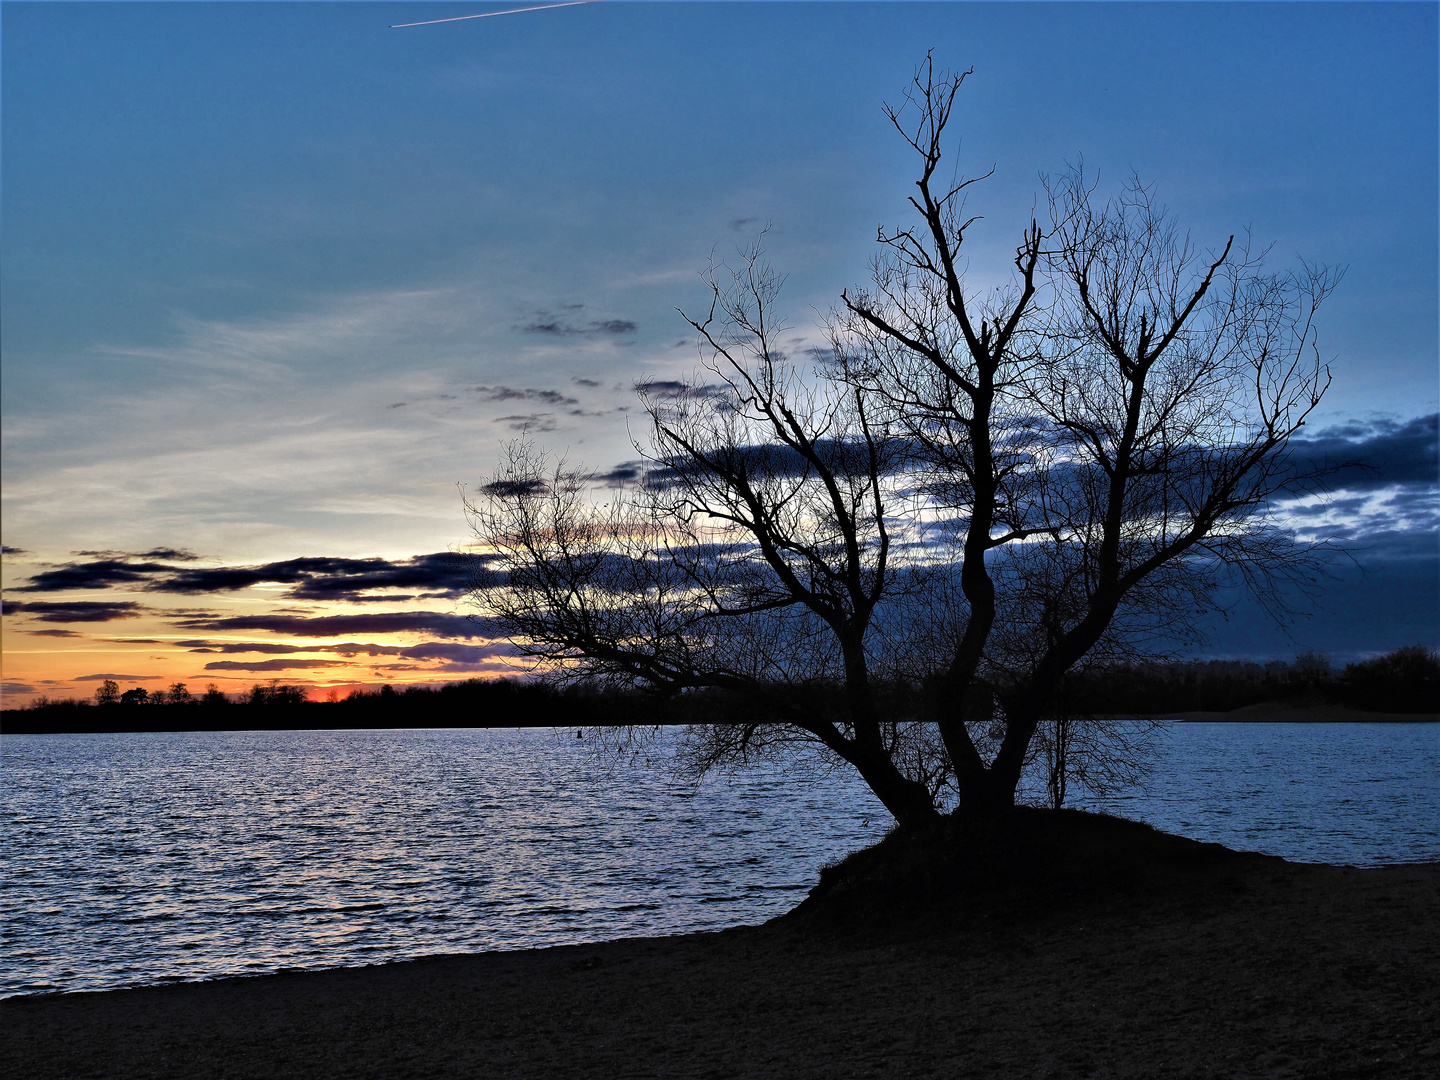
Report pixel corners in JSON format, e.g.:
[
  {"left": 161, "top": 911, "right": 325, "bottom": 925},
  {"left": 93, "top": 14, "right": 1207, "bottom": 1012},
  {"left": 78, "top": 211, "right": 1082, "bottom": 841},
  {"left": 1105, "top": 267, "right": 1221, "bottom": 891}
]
[{"left": 467, "top": 248, "right": 946, "bottom": 821}]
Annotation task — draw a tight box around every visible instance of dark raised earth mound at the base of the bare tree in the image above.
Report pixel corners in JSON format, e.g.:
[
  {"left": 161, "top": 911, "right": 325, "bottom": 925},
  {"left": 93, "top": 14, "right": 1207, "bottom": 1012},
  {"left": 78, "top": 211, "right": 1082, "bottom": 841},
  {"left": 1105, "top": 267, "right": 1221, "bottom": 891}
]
[{"left": 782, "top": 806, "right": 1290, "bottom": 929}]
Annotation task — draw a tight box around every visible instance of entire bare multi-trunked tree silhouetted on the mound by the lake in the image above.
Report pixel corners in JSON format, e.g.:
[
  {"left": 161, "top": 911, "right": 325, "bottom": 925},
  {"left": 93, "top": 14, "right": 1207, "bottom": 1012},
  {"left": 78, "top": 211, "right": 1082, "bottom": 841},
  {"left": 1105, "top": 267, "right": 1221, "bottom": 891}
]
[{"left": 467, "top": 60, "right": 1338, "bottom": 822}]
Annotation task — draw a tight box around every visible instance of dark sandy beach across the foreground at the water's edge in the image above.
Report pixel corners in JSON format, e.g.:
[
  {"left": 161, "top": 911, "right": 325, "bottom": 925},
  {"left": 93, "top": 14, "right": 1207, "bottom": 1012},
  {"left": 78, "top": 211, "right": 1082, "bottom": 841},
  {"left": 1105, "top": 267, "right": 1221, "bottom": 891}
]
[{"left": 0, "top": 827, "right": 1440, "bottom": 1080}]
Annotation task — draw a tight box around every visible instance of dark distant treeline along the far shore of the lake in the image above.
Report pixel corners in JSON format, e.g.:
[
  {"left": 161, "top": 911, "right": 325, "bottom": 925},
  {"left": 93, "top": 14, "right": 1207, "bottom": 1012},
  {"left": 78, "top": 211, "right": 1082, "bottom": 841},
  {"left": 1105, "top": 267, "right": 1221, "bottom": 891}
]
[{"left": 0, "top": 645, "right": 1440, "bottom": 734}]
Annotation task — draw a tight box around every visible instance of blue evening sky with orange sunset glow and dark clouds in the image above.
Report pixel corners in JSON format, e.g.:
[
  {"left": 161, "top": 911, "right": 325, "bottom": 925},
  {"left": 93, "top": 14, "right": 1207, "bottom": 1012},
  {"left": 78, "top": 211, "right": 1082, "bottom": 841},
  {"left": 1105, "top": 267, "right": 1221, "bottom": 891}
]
[{"left": 0, "top": 0, "right": 1440, "bottom": 706}]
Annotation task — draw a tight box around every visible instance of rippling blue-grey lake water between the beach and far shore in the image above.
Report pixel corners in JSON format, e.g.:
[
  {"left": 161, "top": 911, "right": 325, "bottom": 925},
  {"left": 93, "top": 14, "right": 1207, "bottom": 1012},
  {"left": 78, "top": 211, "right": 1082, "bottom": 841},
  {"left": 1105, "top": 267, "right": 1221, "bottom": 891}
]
[{"left": 0, "top": 723, "right": 1440, "bottom": 995}]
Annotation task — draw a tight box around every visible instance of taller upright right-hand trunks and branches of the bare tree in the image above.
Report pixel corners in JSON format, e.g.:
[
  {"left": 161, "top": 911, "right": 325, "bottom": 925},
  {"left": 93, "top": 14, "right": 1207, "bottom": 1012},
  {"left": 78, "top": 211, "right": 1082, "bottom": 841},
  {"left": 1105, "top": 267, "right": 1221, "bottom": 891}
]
[{"left": 841, "top": 60, "right": 1339, "bottom": 806}]
